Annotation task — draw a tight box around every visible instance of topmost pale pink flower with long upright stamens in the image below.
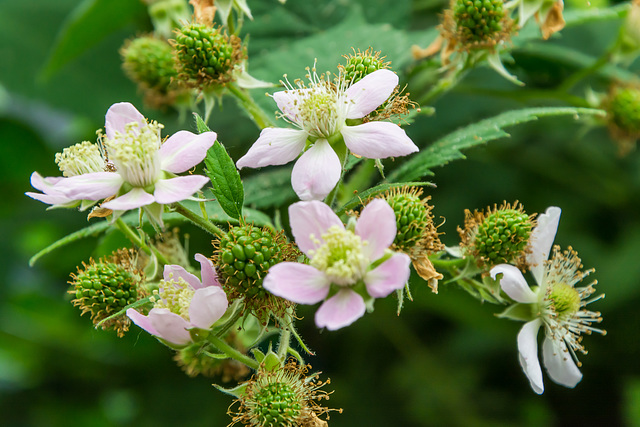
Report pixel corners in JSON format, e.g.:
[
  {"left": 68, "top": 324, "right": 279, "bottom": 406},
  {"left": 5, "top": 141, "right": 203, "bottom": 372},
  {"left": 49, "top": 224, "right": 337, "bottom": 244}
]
[{"left": 237, "top": 69, "right": 418, "bottom": 200}]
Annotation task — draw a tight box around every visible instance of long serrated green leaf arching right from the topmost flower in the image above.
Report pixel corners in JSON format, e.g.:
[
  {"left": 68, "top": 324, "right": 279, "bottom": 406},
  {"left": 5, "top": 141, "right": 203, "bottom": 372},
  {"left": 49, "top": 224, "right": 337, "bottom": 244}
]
[{"left": 388, "top": 107, "right": 605, "bottom": 181}]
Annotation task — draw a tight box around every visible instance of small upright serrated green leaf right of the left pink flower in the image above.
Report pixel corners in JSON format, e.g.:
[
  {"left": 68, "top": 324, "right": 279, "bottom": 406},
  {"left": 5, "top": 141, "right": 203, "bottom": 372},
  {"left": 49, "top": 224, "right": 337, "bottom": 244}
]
[{"left": 204, "top": 141, "right": 244, "bottom": 221}]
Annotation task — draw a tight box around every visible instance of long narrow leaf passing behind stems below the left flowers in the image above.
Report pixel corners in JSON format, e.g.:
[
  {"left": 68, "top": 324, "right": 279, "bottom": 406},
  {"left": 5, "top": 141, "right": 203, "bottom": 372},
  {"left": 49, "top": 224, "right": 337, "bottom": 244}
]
[{"left": 29, "top": 200, "right": 272, "bottom": 266}]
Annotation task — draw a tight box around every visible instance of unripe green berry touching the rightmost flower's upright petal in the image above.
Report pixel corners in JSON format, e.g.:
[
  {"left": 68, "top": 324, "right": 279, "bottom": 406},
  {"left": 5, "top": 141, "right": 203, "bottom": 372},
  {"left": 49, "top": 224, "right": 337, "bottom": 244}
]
[{"left": 458, "top": 201, "right": 535, "bottom": 270}]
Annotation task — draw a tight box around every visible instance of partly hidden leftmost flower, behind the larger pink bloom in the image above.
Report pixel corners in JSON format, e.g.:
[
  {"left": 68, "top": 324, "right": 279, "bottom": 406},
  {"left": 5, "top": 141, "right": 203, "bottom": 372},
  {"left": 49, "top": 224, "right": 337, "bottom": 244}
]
[{"left": 25, "top": 141, "right": 106, "bottom": 210}]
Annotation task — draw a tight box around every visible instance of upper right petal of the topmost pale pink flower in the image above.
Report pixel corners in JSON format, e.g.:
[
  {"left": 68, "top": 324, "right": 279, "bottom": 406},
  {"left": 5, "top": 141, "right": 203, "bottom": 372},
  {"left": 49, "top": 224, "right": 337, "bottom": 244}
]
[{"left": 347, "top": 69, "right": 398, "bottom": 119}]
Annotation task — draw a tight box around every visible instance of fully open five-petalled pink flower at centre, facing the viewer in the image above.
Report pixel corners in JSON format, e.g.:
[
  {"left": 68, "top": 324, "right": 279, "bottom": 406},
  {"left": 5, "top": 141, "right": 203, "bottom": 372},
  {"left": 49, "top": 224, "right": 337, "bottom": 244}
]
[{"left": 263, "top": 199, "right": 411, "bottom": 330}]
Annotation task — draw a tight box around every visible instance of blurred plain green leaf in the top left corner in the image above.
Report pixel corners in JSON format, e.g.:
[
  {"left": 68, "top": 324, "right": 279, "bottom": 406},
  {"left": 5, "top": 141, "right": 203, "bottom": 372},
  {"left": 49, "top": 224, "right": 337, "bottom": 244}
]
[{"left": 41, "top": 0, "right": 145, "bottom": 79}]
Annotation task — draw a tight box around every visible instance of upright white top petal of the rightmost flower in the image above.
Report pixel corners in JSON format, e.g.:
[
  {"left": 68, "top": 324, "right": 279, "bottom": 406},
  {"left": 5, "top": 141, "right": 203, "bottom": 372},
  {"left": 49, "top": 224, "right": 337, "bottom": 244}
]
[{"left": 527, "top": 206, "right": 562, "bottom": 285}]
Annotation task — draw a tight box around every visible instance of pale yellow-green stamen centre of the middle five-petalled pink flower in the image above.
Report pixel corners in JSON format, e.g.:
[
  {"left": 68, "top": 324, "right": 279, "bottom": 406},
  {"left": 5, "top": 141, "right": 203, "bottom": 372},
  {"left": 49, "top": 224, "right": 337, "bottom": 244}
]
[{"left": 310, "top": 225, "right": 369, "bottom": 286}]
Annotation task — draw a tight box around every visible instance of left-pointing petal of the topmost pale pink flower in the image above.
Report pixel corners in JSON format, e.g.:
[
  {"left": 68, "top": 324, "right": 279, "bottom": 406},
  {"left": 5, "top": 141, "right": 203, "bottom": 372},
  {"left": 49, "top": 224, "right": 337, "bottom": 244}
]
[{"left": 236, "top": 128, "right": 307, "bottom": 169}]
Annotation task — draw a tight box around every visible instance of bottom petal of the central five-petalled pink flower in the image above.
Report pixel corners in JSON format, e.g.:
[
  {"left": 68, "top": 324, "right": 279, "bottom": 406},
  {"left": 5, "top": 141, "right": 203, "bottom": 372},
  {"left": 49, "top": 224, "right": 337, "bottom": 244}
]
[{"left": 316, "top": 289, "right": 366, "bottom": 331}]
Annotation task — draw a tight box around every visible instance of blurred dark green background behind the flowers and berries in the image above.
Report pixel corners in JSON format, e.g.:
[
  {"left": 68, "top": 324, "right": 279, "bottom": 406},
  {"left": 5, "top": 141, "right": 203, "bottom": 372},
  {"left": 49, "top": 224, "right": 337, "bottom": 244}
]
[{"left": 0, "top": 0, "right": 640, "bottom": 427}]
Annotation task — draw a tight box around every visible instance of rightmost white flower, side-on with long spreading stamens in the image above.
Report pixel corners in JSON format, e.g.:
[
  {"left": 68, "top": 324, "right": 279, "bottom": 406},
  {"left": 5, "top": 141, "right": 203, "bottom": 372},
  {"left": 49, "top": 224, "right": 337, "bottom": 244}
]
[{"left": 491, "top": 207, "right": 605, "bottom": 394}]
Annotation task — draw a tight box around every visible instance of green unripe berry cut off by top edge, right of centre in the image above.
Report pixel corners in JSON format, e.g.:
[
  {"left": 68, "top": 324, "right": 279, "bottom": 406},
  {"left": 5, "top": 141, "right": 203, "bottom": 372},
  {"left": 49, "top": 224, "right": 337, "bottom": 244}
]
[{"left": 453, "top": 0, "right": 505, "bottom": 43}]
